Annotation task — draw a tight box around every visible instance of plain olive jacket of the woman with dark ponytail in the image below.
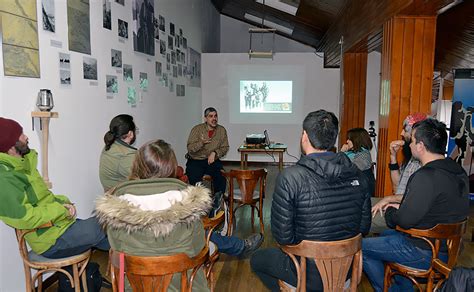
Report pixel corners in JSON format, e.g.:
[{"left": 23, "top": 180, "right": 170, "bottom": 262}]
[{"left": 99, "top": 140, "right": 137, "bottom": 191}]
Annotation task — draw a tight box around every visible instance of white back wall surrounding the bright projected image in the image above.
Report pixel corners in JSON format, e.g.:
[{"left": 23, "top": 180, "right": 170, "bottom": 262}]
[{"left": 202, "top": 53, "right": 339, "bottom": 161}]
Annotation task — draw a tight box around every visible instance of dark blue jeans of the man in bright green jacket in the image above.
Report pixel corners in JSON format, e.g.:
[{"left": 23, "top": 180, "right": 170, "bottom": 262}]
[{"left": 41, "top": 217, "right": 110, "bottom": 259}]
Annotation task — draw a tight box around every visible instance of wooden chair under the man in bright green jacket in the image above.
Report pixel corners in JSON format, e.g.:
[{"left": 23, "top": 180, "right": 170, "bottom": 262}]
[{"left": 15, "top": 223, "right": 91, "bottom": 292}]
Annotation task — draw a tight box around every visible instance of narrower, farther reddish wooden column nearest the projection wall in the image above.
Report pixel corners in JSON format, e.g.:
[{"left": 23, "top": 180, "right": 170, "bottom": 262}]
[{"left": 339, "top": 53, "right": 367, "bottom": 146}]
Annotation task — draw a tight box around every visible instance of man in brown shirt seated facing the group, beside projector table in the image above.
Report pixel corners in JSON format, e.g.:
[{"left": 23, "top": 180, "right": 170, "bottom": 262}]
[{"left": 186, "top": 107, "right": 229, "bottom": 194}]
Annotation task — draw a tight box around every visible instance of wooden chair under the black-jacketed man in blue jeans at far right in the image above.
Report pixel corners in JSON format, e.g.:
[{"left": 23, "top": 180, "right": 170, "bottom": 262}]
[{"left": 384, "top": 220, "right": 467, "bottom": 291}]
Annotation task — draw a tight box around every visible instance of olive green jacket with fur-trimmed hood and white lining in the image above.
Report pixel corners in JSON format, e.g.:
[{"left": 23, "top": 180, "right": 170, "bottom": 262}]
[{"left": 95, "top": 178, "right": 211, "bottom": 291}]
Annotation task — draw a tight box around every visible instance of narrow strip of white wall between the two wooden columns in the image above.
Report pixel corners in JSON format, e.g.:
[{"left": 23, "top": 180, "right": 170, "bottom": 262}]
[{"left": 364, "top": 51, "right": 382, "bottom": 162}]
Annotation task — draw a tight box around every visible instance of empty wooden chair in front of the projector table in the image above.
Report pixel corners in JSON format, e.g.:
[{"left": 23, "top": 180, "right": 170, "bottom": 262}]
[{"left": 222, "top": 168, "right": 267, "bottom": 235}]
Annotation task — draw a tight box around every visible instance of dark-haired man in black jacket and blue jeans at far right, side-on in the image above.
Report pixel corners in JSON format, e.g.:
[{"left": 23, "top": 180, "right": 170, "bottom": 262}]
[{"left": 362, "top": 119, "right": 469, "bottom": 291}]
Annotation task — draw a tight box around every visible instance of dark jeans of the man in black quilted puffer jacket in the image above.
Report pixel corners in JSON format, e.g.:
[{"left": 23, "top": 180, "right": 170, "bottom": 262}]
[{"left": 250, "top": 248, "right": 323, "bottom": 292}]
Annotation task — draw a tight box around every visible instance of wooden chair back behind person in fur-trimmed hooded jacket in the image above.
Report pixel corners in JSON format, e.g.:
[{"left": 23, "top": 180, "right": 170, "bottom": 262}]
[{"left": 109, "top": 245, "right": 209, "bottom": 292}]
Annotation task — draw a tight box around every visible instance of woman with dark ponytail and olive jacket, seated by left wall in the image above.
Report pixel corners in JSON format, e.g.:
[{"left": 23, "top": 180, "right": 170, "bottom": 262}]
[{"left": 99, "top": 114, "right": 138, "bottom": 191}]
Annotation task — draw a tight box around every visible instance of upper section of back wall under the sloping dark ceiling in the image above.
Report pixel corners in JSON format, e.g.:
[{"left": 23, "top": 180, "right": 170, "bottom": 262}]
[{"left": 221, "top": 15, "right": 315, "bottom": 53}]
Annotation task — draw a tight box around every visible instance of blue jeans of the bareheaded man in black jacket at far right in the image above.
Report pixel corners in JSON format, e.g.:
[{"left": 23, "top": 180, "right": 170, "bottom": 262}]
[{"left": 362, "top": 230, "right": 447, "bottom": 291}]
